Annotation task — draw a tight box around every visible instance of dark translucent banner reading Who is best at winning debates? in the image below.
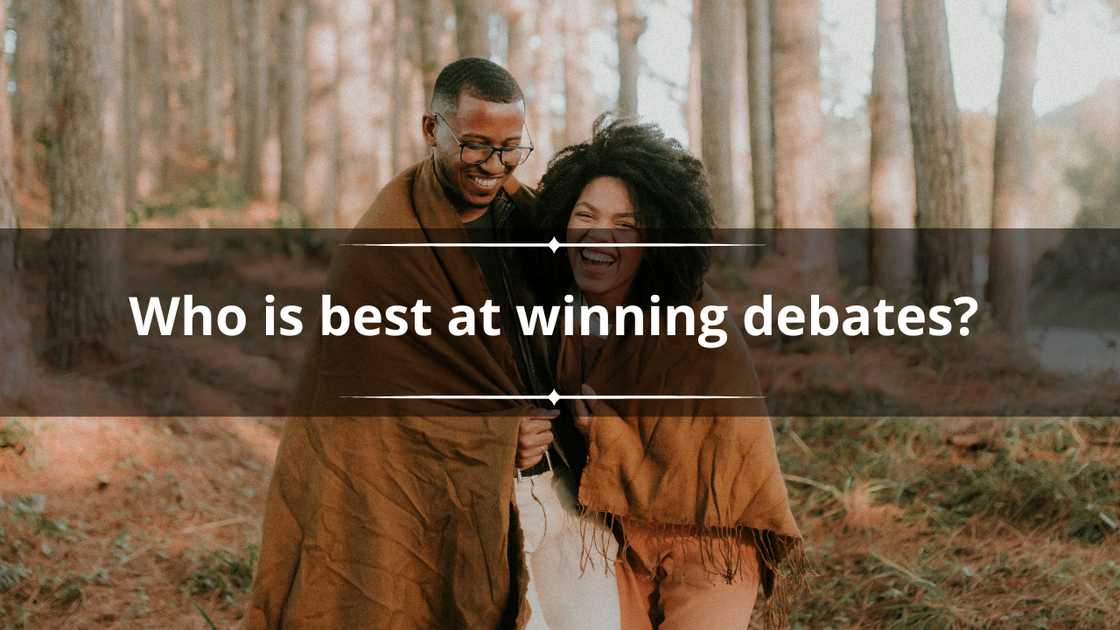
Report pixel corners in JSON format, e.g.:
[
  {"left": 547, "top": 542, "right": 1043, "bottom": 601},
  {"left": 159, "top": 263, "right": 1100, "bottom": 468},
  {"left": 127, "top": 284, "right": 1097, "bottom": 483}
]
[{"left": 0, "top": 230, "right": 1120, "bottom": 417}]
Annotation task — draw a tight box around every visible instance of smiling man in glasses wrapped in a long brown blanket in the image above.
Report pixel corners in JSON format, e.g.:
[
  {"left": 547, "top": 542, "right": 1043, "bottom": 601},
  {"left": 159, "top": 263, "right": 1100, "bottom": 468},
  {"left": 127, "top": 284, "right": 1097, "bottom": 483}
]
[{"left": 246, "top": 58, "right": 556, "bottom": 630}]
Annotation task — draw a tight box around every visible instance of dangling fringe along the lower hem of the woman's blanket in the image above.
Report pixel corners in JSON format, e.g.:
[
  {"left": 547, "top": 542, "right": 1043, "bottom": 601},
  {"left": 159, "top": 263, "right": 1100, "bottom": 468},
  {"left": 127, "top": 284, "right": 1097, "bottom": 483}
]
[{"left": 579, "top": 507, "right": 812, "bottom": 629}]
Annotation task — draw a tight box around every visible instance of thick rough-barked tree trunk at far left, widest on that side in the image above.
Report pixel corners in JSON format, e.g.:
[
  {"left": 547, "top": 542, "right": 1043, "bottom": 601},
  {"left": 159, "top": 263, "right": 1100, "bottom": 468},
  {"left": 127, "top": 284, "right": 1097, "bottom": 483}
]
[{"left": 47, "top": 0, "right": 124, "bottom": 369}]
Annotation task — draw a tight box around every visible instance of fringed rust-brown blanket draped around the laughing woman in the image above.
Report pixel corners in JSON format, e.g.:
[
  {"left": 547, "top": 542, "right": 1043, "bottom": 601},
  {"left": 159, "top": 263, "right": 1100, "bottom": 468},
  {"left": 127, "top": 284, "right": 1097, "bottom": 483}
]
[{"left": 557, "top": 287, "right": 803, "bottom": 626}]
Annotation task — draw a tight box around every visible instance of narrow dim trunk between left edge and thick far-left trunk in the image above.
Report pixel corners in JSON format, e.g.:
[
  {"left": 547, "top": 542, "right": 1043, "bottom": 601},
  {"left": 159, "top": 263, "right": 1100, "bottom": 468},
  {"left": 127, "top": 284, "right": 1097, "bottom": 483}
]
[{"left": 11, "top": 0, "right": 50, "bottom": 191}]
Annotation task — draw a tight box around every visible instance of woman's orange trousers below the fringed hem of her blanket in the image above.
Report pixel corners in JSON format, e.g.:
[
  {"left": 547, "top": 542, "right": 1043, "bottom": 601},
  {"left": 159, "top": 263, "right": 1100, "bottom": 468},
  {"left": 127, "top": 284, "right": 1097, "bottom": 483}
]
[{"left": 615, "top": 525, "right": 759, "bottom": 630}]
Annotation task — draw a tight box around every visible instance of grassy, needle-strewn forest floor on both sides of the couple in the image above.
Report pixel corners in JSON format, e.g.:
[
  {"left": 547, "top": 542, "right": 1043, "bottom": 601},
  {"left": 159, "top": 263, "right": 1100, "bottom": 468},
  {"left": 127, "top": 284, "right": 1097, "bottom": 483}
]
[{"left": 0, "top": 169, "right": 1120, "bottom": 629}]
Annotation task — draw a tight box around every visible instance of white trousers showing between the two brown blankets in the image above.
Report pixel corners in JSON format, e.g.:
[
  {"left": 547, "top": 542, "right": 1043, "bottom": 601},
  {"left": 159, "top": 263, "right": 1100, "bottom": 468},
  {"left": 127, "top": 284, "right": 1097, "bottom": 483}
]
[{"left": 515, "top": 471, "right": 622, "bottom": 630}]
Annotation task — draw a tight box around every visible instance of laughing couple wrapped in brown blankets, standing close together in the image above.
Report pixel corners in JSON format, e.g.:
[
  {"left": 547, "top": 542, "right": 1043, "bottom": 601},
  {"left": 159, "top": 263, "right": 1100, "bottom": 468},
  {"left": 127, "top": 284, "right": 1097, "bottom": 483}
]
[{"left": 246, "top": 58, "right": 801, "bottom": 630}]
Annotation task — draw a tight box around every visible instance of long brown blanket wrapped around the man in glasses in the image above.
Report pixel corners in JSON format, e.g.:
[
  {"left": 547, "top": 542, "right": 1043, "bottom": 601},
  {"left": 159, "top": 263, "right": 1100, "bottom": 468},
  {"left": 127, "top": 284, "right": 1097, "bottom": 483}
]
[{"left": 245, "top": 160, "right": 529, "bottom": 630}]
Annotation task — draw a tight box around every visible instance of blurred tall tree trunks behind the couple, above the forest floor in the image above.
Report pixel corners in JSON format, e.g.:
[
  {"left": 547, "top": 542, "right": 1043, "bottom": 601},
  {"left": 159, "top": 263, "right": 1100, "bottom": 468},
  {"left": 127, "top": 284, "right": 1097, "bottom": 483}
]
[{"left": 0, "top": 0, "right": 1120, "bottom": 365}]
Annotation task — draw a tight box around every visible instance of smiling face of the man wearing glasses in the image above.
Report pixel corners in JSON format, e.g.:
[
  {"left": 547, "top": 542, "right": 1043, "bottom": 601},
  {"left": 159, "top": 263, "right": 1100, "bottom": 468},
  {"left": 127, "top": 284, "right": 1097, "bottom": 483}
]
[{"left": 423, "top": 94, "right": 528, "bottom": 209}]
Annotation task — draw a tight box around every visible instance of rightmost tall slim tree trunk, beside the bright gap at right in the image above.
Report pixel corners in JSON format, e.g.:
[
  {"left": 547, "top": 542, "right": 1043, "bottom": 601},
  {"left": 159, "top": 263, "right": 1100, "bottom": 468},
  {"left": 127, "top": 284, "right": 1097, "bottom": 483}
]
[{"left": 988, "top": 0, "right": 1043, "bottom": 339}]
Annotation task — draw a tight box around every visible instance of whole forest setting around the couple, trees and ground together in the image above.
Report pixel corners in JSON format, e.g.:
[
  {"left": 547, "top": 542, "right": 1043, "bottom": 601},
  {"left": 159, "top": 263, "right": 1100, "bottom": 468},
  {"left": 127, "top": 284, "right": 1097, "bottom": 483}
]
[{"left": 0, "top": 0, "right": 1120, "bottom": 629}]
